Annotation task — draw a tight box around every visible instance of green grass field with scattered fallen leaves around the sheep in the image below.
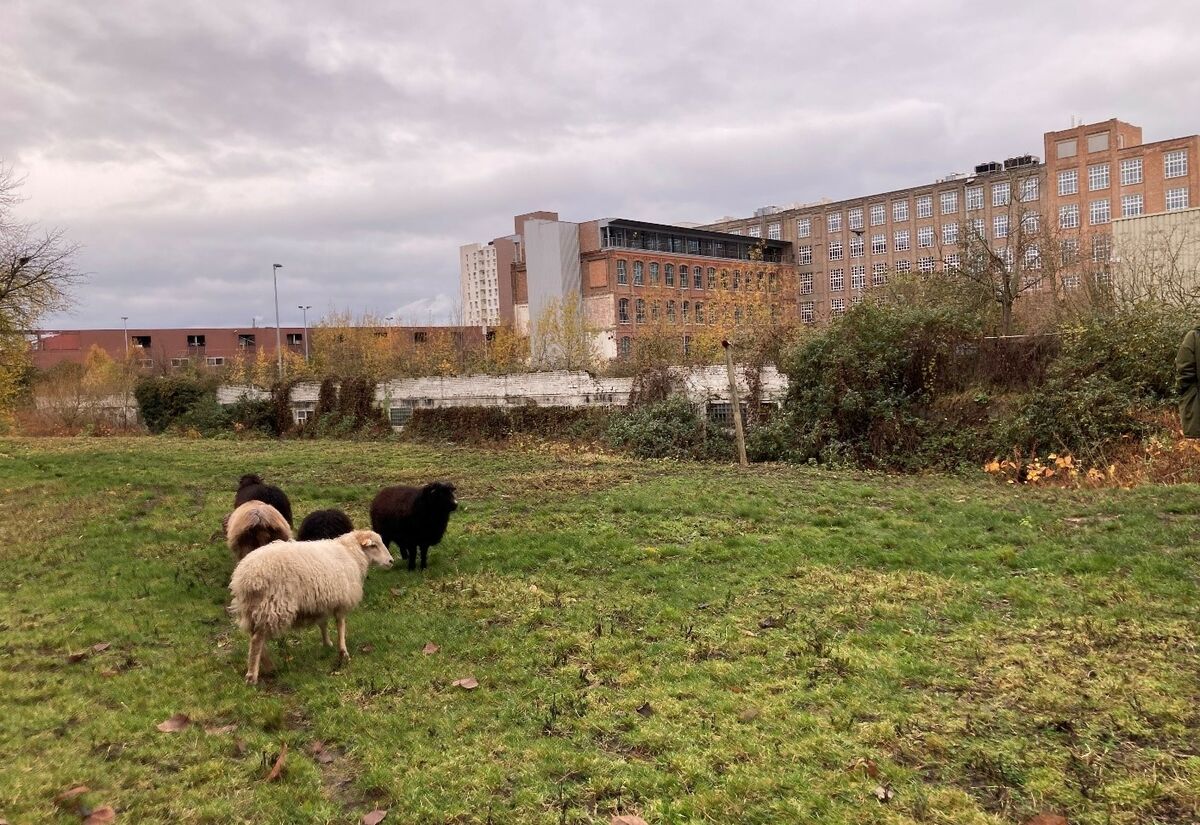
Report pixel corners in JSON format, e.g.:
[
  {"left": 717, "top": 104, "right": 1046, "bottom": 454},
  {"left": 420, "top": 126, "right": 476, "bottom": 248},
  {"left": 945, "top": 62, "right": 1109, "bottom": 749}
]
[{"left": 0, "top": 438, "right": 1200, "bottom": 825}]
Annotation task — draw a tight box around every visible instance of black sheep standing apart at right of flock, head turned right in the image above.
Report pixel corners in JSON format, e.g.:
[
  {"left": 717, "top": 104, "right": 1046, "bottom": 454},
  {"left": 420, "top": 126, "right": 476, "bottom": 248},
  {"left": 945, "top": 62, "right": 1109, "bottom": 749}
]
[{"left": 371, "top": 481, "right": 458, "bottom": 570}]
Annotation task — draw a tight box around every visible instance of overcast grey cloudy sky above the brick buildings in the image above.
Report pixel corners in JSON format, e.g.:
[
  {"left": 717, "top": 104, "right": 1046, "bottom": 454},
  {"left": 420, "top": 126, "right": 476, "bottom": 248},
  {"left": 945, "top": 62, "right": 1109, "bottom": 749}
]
[{"left": 0, "top": 0, "right": 1200, "bottom": 329}]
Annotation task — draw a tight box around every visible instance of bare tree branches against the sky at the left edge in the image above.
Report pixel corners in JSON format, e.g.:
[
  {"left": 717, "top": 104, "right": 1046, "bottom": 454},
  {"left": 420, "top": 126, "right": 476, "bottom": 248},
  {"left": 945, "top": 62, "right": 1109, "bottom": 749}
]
[{"left": 0, "top": 167, "right": 82, "bottom": 335}]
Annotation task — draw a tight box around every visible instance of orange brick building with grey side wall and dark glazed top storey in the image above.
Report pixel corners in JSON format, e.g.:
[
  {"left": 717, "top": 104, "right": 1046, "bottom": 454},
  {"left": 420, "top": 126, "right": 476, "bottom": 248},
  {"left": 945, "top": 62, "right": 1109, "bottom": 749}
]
[{"left": 511, "top": 216, "right": 794, "bottom": 359}]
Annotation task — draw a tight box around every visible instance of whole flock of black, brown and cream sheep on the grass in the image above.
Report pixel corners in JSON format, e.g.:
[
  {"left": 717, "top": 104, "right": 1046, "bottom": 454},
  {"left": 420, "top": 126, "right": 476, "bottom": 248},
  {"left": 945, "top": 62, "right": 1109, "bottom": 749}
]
[{"left": 224, "top": 475, "right": 458, "bottom": 685}]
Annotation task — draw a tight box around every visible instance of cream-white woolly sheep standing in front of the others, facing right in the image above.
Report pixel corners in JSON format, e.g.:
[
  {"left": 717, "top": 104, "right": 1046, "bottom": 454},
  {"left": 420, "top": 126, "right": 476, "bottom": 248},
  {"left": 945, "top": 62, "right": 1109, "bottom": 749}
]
[{"left": 229, "top": 530, "right": 391, "bottom": 685}]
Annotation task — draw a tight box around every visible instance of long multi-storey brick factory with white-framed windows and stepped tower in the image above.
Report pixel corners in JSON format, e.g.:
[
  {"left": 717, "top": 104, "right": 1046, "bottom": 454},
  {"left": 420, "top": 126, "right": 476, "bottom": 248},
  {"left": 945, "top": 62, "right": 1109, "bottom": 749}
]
[{"left": 707, "top": 119, "right": 1200, "bottom": 323}]
